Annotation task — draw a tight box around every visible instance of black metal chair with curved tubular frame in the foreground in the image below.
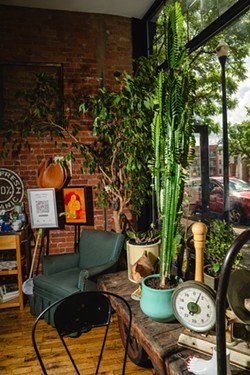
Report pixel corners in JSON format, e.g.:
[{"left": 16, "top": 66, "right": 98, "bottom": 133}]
[{"left": 32, "top": 291, "right": 132, "bottom": 375}]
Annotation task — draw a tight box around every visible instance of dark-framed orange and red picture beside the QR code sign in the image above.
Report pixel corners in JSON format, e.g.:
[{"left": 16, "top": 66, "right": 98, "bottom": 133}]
[{"left": 63, "top": 186, "right": 94, "bottom": 225}]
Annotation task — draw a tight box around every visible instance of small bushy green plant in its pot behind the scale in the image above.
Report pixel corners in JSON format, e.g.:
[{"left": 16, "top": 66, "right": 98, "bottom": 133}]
[{"left": 204, "top": 219, "right": 242, "bottom": 290}]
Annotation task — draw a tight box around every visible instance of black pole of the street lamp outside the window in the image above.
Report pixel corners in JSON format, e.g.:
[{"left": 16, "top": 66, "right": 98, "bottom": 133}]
[{"left": 219, "top": 56, "right": 230, "bottom": 224}]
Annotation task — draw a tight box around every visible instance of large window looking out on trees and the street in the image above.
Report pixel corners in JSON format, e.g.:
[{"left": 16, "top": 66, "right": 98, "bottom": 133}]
[{"left": 149, "top": 0, "right": 250, "bottom": 225}]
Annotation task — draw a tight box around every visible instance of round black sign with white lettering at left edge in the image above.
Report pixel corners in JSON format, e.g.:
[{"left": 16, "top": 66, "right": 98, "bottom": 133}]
[{"left": 0, "top": 168, "right": 24, "bottom": 211}]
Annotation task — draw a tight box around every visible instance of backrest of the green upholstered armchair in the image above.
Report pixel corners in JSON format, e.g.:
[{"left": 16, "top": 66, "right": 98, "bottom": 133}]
[{"left": 79, "top": 229, "right": 125, "bottom": 268}]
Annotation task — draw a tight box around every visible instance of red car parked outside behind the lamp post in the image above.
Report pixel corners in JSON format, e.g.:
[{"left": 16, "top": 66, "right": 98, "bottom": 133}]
[{"left": 184, "top": 176, "right": 250, "bottom": 225}]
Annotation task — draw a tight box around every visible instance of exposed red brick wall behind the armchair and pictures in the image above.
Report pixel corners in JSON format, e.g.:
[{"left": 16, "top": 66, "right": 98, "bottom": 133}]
[{"left": 0, "top": 6, "right": 132, "bottom": 253}]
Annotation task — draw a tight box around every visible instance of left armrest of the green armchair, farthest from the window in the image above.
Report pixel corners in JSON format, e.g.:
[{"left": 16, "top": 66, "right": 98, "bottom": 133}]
[{"left": 43, "top": 253, "right": 80, "bottom": 275}]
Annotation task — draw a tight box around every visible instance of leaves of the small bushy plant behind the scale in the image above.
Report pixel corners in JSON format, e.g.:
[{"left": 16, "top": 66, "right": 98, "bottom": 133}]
[{"left": 204, "top": 219, "right": 242, "bottom": 274}]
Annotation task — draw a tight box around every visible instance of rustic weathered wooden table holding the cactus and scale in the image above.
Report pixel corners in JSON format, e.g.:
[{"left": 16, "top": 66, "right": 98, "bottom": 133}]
[{"left": 98, "top": 271, "right": 249, "bottom": 375}]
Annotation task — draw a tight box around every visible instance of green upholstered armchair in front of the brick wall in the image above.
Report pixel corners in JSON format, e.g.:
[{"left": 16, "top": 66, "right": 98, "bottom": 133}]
[{"left": 30, "top": 229, "right": 125, "bottom": 325}]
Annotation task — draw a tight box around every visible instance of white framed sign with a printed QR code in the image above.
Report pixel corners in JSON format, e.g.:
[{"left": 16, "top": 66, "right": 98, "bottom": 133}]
[{"left": 27, "top": 188, "right": 58, "bottom": 228}]
